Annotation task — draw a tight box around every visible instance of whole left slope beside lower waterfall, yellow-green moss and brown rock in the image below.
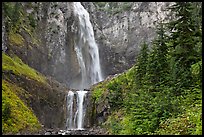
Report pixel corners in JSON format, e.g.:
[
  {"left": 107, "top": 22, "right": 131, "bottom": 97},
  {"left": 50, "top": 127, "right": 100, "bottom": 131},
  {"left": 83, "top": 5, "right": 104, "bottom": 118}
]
[{"left": 2, "top": 53, "right": 67, "bottom": 134}]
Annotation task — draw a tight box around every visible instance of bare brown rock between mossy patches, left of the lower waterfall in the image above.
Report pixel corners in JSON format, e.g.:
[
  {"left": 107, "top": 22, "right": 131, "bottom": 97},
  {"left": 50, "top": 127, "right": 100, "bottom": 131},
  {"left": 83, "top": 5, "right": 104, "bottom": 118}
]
[{"left": 2, "top": 71, "right": 68, "bottom": 129}]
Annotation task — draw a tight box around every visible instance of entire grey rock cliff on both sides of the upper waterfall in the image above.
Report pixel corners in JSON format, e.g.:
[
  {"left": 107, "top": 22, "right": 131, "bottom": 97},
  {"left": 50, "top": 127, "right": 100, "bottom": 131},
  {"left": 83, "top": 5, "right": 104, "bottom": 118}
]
[{"left": 2, "top": 2, "right": 172, "bottom": 86}]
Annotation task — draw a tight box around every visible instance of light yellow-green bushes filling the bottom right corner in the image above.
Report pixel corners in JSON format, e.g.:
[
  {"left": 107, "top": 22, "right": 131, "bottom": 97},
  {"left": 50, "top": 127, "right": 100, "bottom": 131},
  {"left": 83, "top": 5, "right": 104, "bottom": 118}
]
[{"left": 154, "top": 98, "right": 202, "bottom": 135}]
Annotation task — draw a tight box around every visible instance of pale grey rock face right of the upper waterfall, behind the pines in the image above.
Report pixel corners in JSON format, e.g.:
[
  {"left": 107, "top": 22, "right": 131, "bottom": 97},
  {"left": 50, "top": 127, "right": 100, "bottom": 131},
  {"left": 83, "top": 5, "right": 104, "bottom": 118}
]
[{"left": 83, "top": 2, "right": 173, "bottom": 76}]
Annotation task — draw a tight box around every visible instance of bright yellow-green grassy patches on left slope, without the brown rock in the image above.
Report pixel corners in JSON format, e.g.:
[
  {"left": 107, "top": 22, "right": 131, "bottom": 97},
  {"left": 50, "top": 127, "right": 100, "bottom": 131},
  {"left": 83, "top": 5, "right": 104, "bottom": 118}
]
[{"left": 2, "top": 53, "right": 46, "bottom": 134}]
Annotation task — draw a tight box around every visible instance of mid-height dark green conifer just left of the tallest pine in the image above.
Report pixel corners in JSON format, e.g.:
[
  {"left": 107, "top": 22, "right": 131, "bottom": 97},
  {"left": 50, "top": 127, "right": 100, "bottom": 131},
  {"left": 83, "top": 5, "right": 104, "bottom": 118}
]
[{"left": 147, "top": 23, "right": 168, "bottom": 90}]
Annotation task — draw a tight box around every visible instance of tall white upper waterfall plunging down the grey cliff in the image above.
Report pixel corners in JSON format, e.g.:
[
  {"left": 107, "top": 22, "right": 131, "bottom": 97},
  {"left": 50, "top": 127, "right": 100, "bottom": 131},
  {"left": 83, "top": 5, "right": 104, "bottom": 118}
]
[{"left": 70, "top": 2, "right": 103, "bottom": 90}]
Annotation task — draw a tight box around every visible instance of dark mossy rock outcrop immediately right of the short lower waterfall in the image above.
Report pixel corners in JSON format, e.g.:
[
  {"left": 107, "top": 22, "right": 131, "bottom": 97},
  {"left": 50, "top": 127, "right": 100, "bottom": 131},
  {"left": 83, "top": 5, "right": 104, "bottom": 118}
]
[{"left": 85, "top": 74, "right": 116, "bottom": 128}]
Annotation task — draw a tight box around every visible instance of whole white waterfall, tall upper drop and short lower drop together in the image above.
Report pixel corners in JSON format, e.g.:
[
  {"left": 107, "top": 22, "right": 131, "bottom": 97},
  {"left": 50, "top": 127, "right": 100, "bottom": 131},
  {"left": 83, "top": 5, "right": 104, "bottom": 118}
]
[{"left": 66, "top": 2, "right": 103, "bottom": 129}]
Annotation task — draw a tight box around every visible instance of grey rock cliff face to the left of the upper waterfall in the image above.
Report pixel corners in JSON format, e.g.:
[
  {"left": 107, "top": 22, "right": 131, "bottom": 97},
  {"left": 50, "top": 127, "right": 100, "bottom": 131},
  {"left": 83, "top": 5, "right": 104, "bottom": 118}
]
[{"left": 2, "top": 2, "right": 79, "bottom": 86}]
